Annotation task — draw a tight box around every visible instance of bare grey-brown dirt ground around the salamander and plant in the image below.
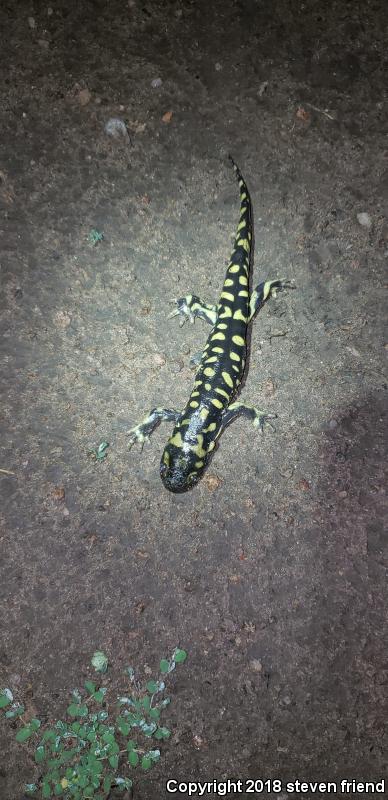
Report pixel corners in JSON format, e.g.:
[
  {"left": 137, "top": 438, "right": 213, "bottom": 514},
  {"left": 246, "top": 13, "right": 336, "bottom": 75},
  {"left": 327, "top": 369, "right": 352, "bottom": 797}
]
[{"left": 0, "top": 0, "right": 388, "bottom": 800}]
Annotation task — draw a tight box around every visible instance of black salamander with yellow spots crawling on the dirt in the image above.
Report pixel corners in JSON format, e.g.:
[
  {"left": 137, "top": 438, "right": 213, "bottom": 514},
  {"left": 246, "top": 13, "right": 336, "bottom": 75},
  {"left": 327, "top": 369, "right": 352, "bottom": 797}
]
[{"left": 128, "top": 158, "right": 290, "bottom": 492}]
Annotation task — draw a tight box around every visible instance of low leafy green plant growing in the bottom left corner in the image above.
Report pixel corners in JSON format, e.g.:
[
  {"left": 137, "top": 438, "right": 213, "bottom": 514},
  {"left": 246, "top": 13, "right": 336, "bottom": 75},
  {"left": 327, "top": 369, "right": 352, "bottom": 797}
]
[{"left": 0, "top": 648, "right": 187, "bottom": 800}]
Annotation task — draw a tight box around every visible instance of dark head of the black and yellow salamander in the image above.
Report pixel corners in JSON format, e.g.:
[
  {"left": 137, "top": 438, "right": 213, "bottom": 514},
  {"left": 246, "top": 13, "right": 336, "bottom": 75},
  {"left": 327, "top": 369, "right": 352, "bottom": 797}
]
[{"left": 160, "top": 442, "right": 206, "bottom": 492}]
